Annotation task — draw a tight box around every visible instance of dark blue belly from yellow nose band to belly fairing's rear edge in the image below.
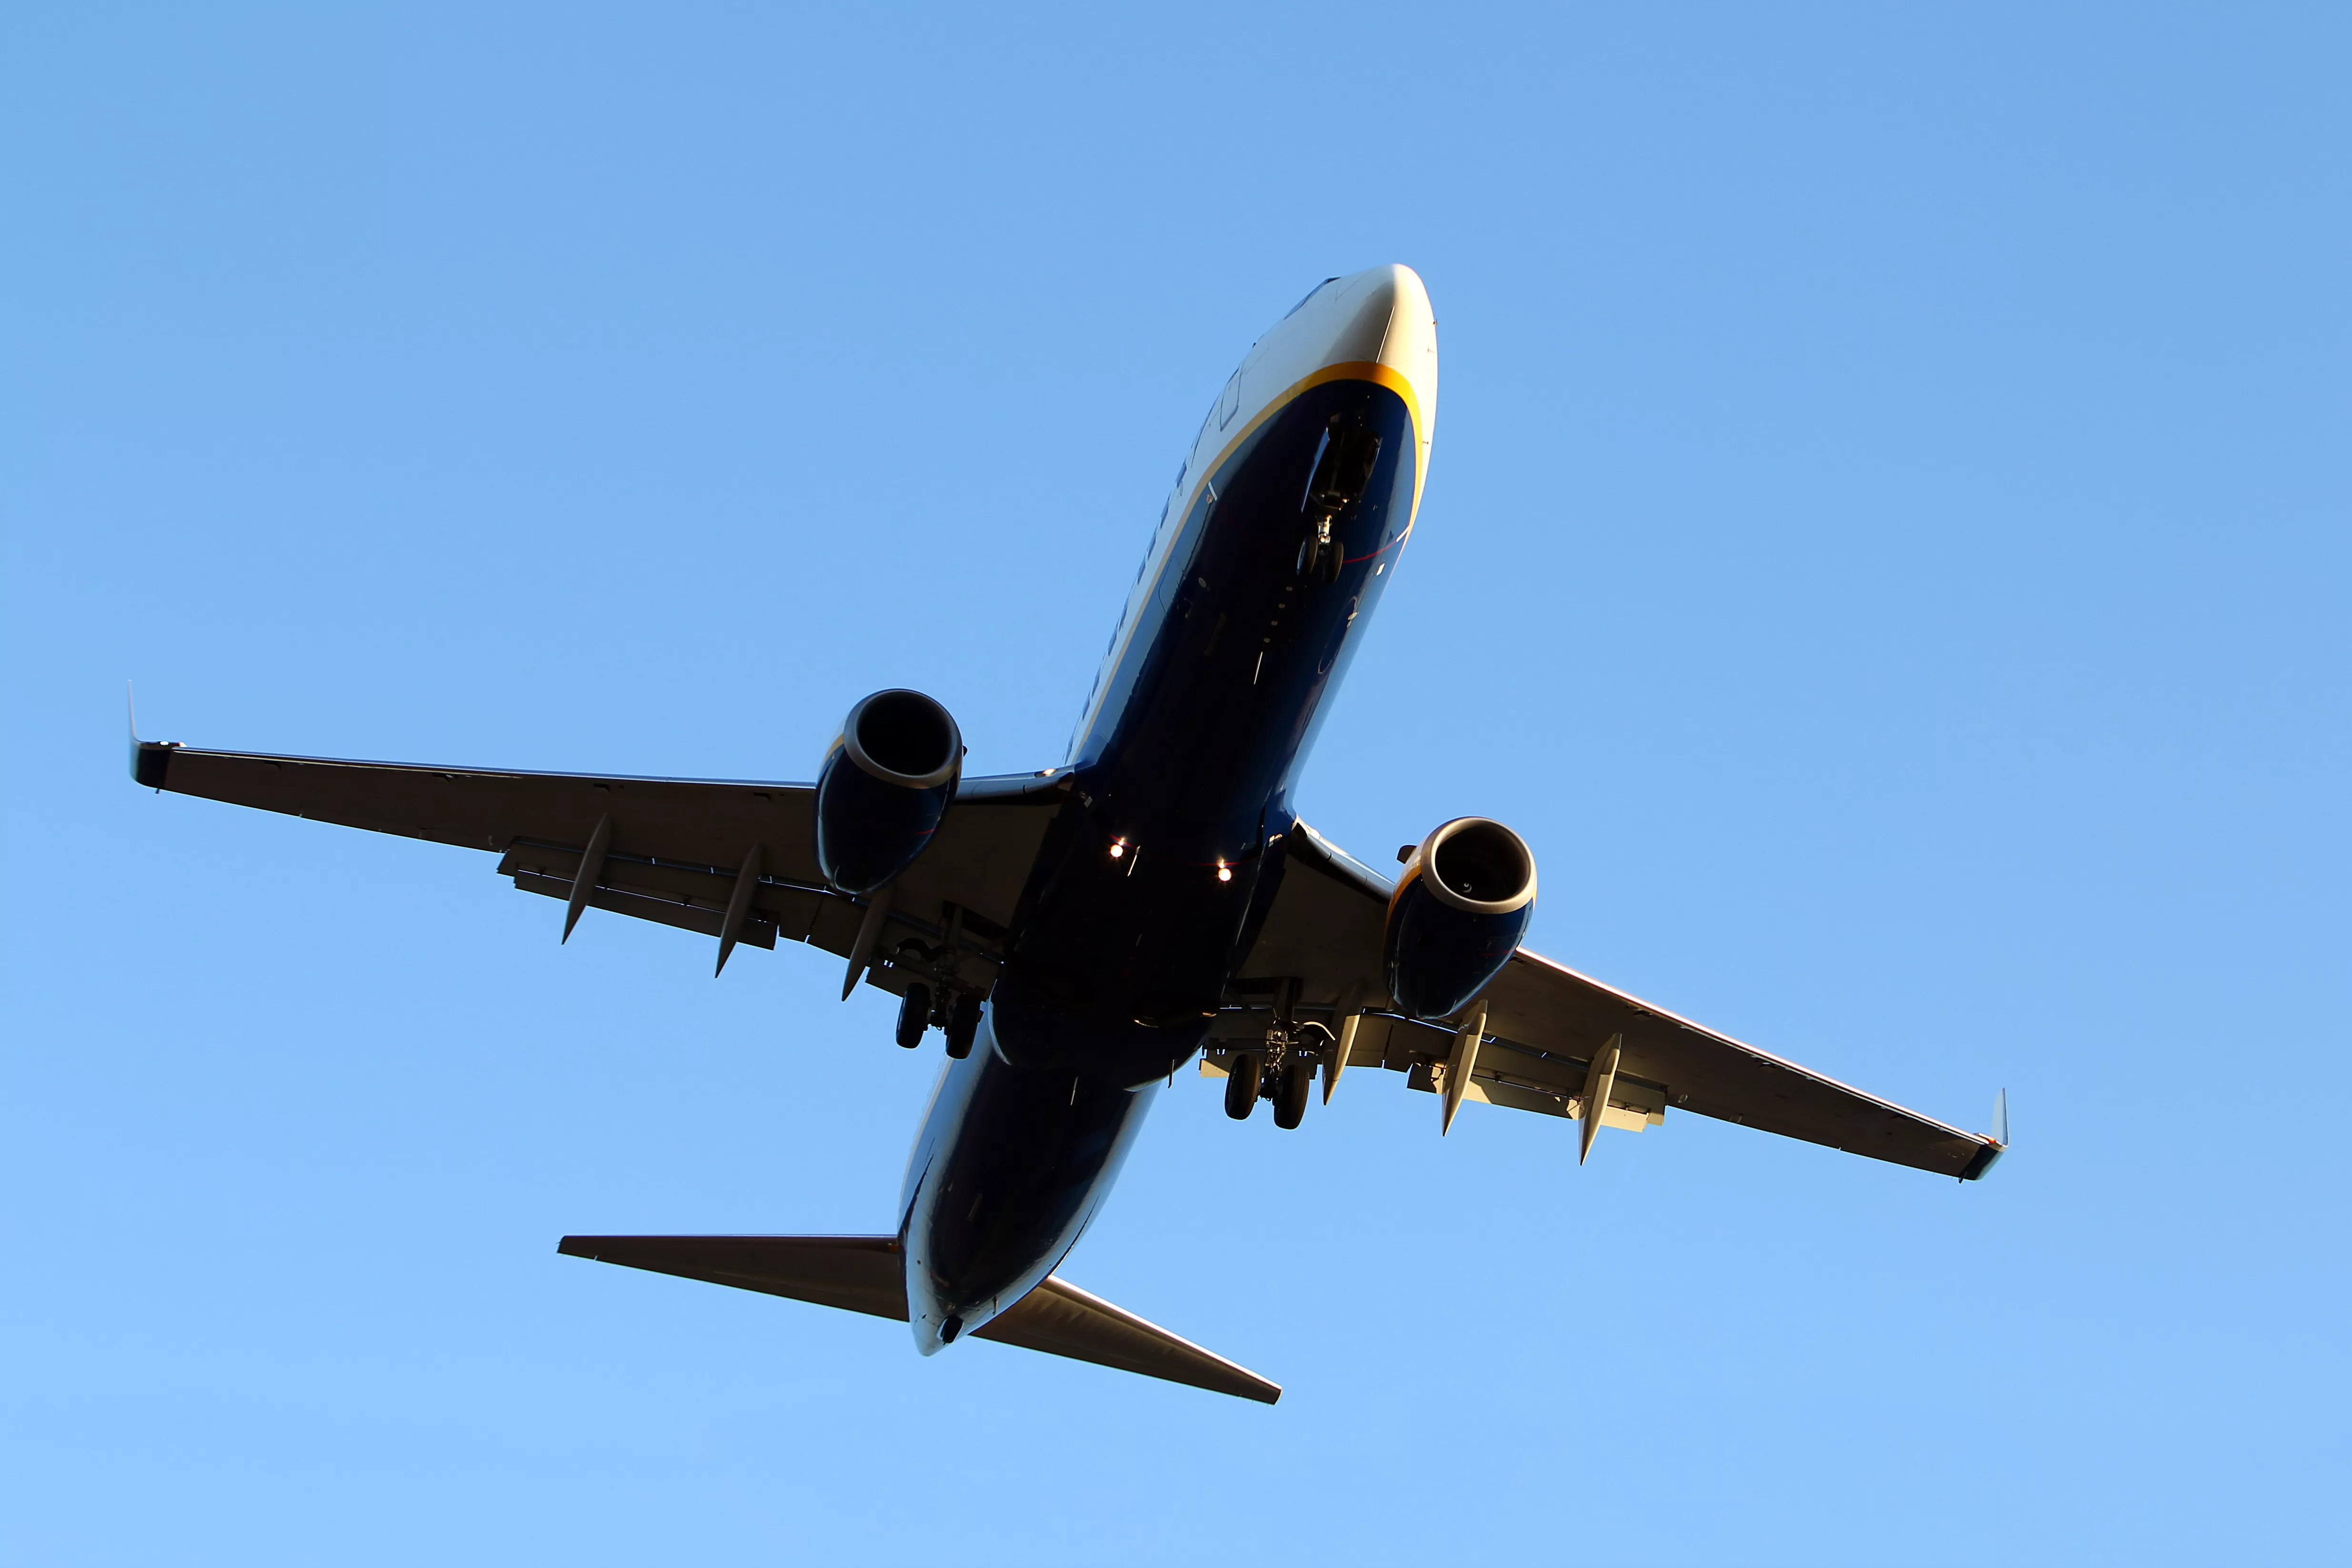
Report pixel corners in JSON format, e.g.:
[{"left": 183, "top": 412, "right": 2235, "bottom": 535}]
[{"left": 997, "top": 381, "right": 1414, "bottom": 1062}]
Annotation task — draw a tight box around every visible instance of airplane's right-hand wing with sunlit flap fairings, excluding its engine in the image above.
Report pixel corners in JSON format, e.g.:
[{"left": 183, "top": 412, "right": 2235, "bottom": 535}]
[{"left": 1202, "top": 823, "right": 2004, "bottom": 1180}]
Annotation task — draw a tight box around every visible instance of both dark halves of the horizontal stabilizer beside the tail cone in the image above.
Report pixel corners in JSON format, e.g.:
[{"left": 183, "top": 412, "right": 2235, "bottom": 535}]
[{"left": 555, "top": 1236, "right": 1282, "bottom": 1404}]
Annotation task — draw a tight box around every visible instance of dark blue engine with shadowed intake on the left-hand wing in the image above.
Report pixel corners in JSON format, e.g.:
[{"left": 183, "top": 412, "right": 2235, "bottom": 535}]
[{"left": 816, "top": 691, "right": 965, "bottom": 898}]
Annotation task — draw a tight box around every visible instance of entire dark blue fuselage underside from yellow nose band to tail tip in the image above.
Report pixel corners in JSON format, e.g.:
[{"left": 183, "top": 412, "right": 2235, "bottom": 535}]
[{"left": 901, "top": 379, "right": 1416, "bottom": 1349}]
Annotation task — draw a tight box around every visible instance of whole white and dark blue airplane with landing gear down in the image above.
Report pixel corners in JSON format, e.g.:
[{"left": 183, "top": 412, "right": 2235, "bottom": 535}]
[{"left": 132, "top": 266, "right": 2009, "bottom": 1404}]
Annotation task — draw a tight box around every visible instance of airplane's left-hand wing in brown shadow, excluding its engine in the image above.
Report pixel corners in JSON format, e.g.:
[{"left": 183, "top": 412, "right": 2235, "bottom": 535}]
[{"left": 132, "top": 741, "right": 1065, "bottom": 992}]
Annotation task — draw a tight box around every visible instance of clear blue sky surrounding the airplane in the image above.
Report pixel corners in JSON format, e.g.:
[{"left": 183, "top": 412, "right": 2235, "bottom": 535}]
[{"left": 0, "top": 5, "right": 2352, "bottom": 1566}]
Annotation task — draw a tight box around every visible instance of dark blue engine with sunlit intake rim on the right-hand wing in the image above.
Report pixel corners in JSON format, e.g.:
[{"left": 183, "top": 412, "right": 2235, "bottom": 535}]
[{"left": 1385, "top": 816, "right": 1536, "bottom": 1018}]
